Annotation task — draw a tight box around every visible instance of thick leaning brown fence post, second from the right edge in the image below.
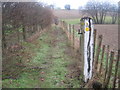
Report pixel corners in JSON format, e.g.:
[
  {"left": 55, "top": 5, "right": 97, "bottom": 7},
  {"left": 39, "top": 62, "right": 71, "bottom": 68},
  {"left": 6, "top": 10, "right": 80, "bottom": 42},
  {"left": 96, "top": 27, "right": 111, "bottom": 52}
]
[{"left": 103, "top": 51, "right": 114, "bottom": 88}]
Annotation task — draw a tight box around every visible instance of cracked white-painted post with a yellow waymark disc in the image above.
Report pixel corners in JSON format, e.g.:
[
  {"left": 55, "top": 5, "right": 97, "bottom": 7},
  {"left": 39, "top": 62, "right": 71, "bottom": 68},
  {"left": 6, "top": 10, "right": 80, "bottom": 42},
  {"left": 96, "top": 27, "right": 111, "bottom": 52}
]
[{"left": 82, "top": 17, "right": 94, "bottom": 82}]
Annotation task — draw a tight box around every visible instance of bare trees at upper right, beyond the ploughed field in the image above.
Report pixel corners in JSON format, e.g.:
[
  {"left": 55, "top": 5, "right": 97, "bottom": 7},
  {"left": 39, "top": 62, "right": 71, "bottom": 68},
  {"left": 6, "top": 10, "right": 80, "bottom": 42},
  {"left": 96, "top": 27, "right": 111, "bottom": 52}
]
[{"left": 82, "top": 1, "right": 117, "bottom": 24}]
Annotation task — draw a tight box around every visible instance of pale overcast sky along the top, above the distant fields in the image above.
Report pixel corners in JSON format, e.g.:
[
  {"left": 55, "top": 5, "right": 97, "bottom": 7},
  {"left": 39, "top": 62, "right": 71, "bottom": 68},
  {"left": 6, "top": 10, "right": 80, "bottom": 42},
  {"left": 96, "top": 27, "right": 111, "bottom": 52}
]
[{"left": 38, "top": 0, "right": 120, "bottom": 9}]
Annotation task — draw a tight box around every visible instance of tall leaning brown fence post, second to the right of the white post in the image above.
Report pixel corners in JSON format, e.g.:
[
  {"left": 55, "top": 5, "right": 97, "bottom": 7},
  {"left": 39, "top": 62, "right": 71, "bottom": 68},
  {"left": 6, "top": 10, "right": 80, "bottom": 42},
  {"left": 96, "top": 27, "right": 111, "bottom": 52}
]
[{"left": 95, "top": 35, "right": 102, "bottom": 72}]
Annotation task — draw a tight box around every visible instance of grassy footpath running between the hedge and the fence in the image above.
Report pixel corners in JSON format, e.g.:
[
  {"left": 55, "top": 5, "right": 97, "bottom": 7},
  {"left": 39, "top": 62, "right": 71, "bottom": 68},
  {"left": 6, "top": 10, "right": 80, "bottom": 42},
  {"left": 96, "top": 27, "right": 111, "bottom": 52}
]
[{"left": 3, "top": 25, "right": 81, "bottom": 88}]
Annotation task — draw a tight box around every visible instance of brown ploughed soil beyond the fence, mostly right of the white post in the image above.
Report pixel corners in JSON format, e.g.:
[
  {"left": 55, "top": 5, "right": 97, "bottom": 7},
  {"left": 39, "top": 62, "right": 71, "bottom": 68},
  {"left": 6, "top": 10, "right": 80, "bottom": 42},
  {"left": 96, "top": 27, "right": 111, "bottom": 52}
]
[{"left": 75, "top": 24, "right": 118, "bottom": 50}]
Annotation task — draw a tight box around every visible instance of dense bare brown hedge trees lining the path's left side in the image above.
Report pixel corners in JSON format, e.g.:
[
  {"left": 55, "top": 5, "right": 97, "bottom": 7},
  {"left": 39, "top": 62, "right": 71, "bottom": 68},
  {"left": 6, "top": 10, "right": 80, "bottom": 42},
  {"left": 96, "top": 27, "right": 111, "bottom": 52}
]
[{"left": 2, "top": 2, "right": 53, "bottom": 47}]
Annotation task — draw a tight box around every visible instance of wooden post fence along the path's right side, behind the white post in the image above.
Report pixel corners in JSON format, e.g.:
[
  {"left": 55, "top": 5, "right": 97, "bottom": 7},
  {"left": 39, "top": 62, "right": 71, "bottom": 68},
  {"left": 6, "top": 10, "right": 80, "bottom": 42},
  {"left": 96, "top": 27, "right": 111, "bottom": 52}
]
[{"left": 60, "top": 21, "right": 120, "bottom": 88}]
